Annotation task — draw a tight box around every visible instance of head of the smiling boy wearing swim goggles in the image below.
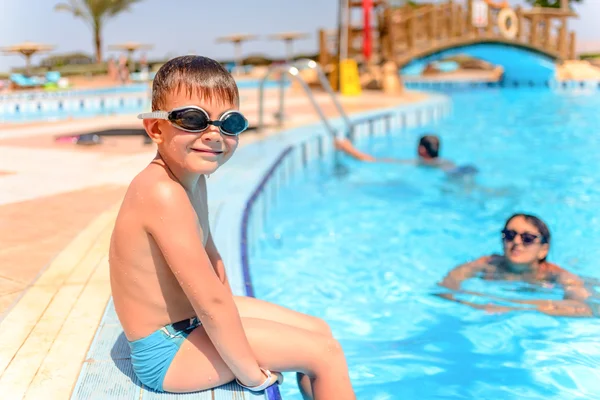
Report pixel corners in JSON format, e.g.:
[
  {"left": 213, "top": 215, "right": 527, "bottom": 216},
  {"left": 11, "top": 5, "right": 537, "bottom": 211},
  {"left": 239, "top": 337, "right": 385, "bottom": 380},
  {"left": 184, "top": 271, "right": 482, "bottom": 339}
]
[{"left": 140, "top": 56, "right": 248, "bottom": 174}]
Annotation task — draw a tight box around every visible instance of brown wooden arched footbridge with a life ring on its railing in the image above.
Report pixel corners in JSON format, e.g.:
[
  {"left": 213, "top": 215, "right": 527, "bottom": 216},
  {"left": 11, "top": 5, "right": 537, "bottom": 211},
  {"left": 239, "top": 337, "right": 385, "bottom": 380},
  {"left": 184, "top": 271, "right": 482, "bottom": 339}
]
[{"left": 319, "top": 0, "right": 577, "bottom": 67}]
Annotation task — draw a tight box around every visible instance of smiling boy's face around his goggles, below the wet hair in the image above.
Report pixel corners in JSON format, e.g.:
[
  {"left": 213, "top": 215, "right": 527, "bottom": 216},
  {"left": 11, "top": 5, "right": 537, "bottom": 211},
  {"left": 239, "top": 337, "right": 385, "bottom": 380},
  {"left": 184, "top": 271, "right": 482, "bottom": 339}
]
[{"left": 146, "top": 90, "right": 239, "bottom": 175}]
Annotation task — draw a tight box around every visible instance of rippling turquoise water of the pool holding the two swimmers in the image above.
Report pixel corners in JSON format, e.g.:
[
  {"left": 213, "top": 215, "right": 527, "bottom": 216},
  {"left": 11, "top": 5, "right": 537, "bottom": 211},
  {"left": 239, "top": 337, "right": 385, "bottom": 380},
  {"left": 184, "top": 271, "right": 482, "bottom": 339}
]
[{"left": 250, "top": 89, "right": 600, "bottom": 400}]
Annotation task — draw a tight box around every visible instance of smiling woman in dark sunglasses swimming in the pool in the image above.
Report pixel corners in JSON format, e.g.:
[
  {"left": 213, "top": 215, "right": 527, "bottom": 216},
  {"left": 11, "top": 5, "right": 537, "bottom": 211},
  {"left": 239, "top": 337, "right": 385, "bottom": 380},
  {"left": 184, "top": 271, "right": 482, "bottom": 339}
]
[{"left": 439, "top": 214, "right": 592, "bottom": 317}]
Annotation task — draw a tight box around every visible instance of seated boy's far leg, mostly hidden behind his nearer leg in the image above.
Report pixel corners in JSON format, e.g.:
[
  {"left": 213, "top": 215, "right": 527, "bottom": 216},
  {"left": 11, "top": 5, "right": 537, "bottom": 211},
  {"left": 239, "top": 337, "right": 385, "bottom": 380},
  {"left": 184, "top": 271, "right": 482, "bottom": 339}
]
[{"left": 234, "top": 296, "right": 332, "bottom": 400}]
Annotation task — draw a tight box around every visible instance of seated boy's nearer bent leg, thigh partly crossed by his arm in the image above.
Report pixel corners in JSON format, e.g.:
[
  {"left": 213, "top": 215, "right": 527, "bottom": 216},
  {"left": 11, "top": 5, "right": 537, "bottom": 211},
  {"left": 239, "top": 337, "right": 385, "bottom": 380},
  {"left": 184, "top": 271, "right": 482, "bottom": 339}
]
[{"left": 163, "top": 318, "right": 355, "bottom": 400}]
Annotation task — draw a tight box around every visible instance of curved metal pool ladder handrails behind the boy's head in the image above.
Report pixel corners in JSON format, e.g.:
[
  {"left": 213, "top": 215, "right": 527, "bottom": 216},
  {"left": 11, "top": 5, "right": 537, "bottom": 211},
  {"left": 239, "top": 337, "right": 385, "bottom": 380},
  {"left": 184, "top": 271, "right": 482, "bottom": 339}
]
[{"left": 257, "top": 59, "right": 352, "bottom": 138}]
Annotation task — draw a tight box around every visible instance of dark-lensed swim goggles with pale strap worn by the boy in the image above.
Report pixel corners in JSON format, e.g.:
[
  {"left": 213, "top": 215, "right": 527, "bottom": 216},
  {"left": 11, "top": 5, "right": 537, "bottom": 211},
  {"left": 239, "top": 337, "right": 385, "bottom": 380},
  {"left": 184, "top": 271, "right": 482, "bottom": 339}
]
[{"left": 138, "top": 106, "right": 248, "bottom": 136}]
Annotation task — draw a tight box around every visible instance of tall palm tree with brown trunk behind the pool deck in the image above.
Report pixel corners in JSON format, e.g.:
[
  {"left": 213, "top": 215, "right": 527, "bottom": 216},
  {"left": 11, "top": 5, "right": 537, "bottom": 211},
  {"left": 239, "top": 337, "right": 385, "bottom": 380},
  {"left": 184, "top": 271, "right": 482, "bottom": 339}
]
[{"left": 54, "top": 0, "right": 142, "bottom": 62}]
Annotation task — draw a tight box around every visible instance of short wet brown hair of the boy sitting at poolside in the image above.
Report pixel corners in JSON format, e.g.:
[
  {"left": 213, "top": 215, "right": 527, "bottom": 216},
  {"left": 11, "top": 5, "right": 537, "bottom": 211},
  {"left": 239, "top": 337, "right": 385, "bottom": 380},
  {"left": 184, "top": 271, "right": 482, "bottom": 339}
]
[{"left": 152, "top": 56, "right": 239, "bottom": 111}]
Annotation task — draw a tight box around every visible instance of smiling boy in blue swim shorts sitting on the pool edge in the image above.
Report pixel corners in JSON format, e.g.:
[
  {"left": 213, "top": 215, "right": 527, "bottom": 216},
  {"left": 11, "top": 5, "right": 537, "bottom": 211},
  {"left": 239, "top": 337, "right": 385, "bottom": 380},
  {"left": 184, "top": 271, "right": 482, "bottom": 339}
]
[{"left": 109, "top": 56, "right": 355, "bottom": 400}]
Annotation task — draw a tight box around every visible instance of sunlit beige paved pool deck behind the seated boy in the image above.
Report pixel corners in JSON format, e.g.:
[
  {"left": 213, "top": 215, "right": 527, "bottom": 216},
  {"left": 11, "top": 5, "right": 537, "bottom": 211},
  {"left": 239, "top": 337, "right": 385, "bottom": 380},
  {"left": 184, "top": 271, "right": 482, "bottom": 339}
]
[{"left": 0, "top": 86, "right": 426, "bottom": 399}]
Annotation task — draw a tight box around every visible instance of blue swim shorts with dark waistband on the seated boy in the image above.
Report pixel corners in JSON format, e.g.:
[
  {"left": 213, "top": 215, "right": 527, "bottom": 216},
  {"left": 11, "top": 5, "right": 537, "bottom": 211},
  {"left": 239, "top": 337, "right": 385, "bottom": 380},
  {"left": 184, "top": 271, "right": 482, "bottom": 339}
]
[{"left": 129, "top": 317, "right": 200, "bottom": 392}]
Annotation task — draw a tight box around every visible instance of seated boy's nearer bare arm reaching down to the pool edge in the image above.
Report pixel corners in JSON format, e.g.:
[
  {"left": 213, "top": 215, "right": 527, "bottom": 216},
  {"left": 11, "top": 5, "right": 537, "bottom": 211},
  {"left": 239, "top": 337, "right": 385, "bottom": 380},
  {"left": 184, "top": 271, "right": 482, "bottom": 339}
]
[{"left": 142, "top": 182, "right": 265, "bottom": 386}]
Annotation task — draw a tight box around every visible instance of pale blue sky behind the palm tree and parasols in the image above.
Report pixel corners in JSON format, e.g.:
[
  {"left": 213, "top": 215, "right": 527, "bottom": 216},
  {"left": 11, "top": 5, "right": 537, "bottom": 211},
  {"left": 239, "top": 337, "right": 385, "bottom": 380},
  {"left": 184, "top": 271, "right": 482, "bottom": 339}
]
[{"left": 0, "top": 0, "right": 600, "bottom": 71}]
